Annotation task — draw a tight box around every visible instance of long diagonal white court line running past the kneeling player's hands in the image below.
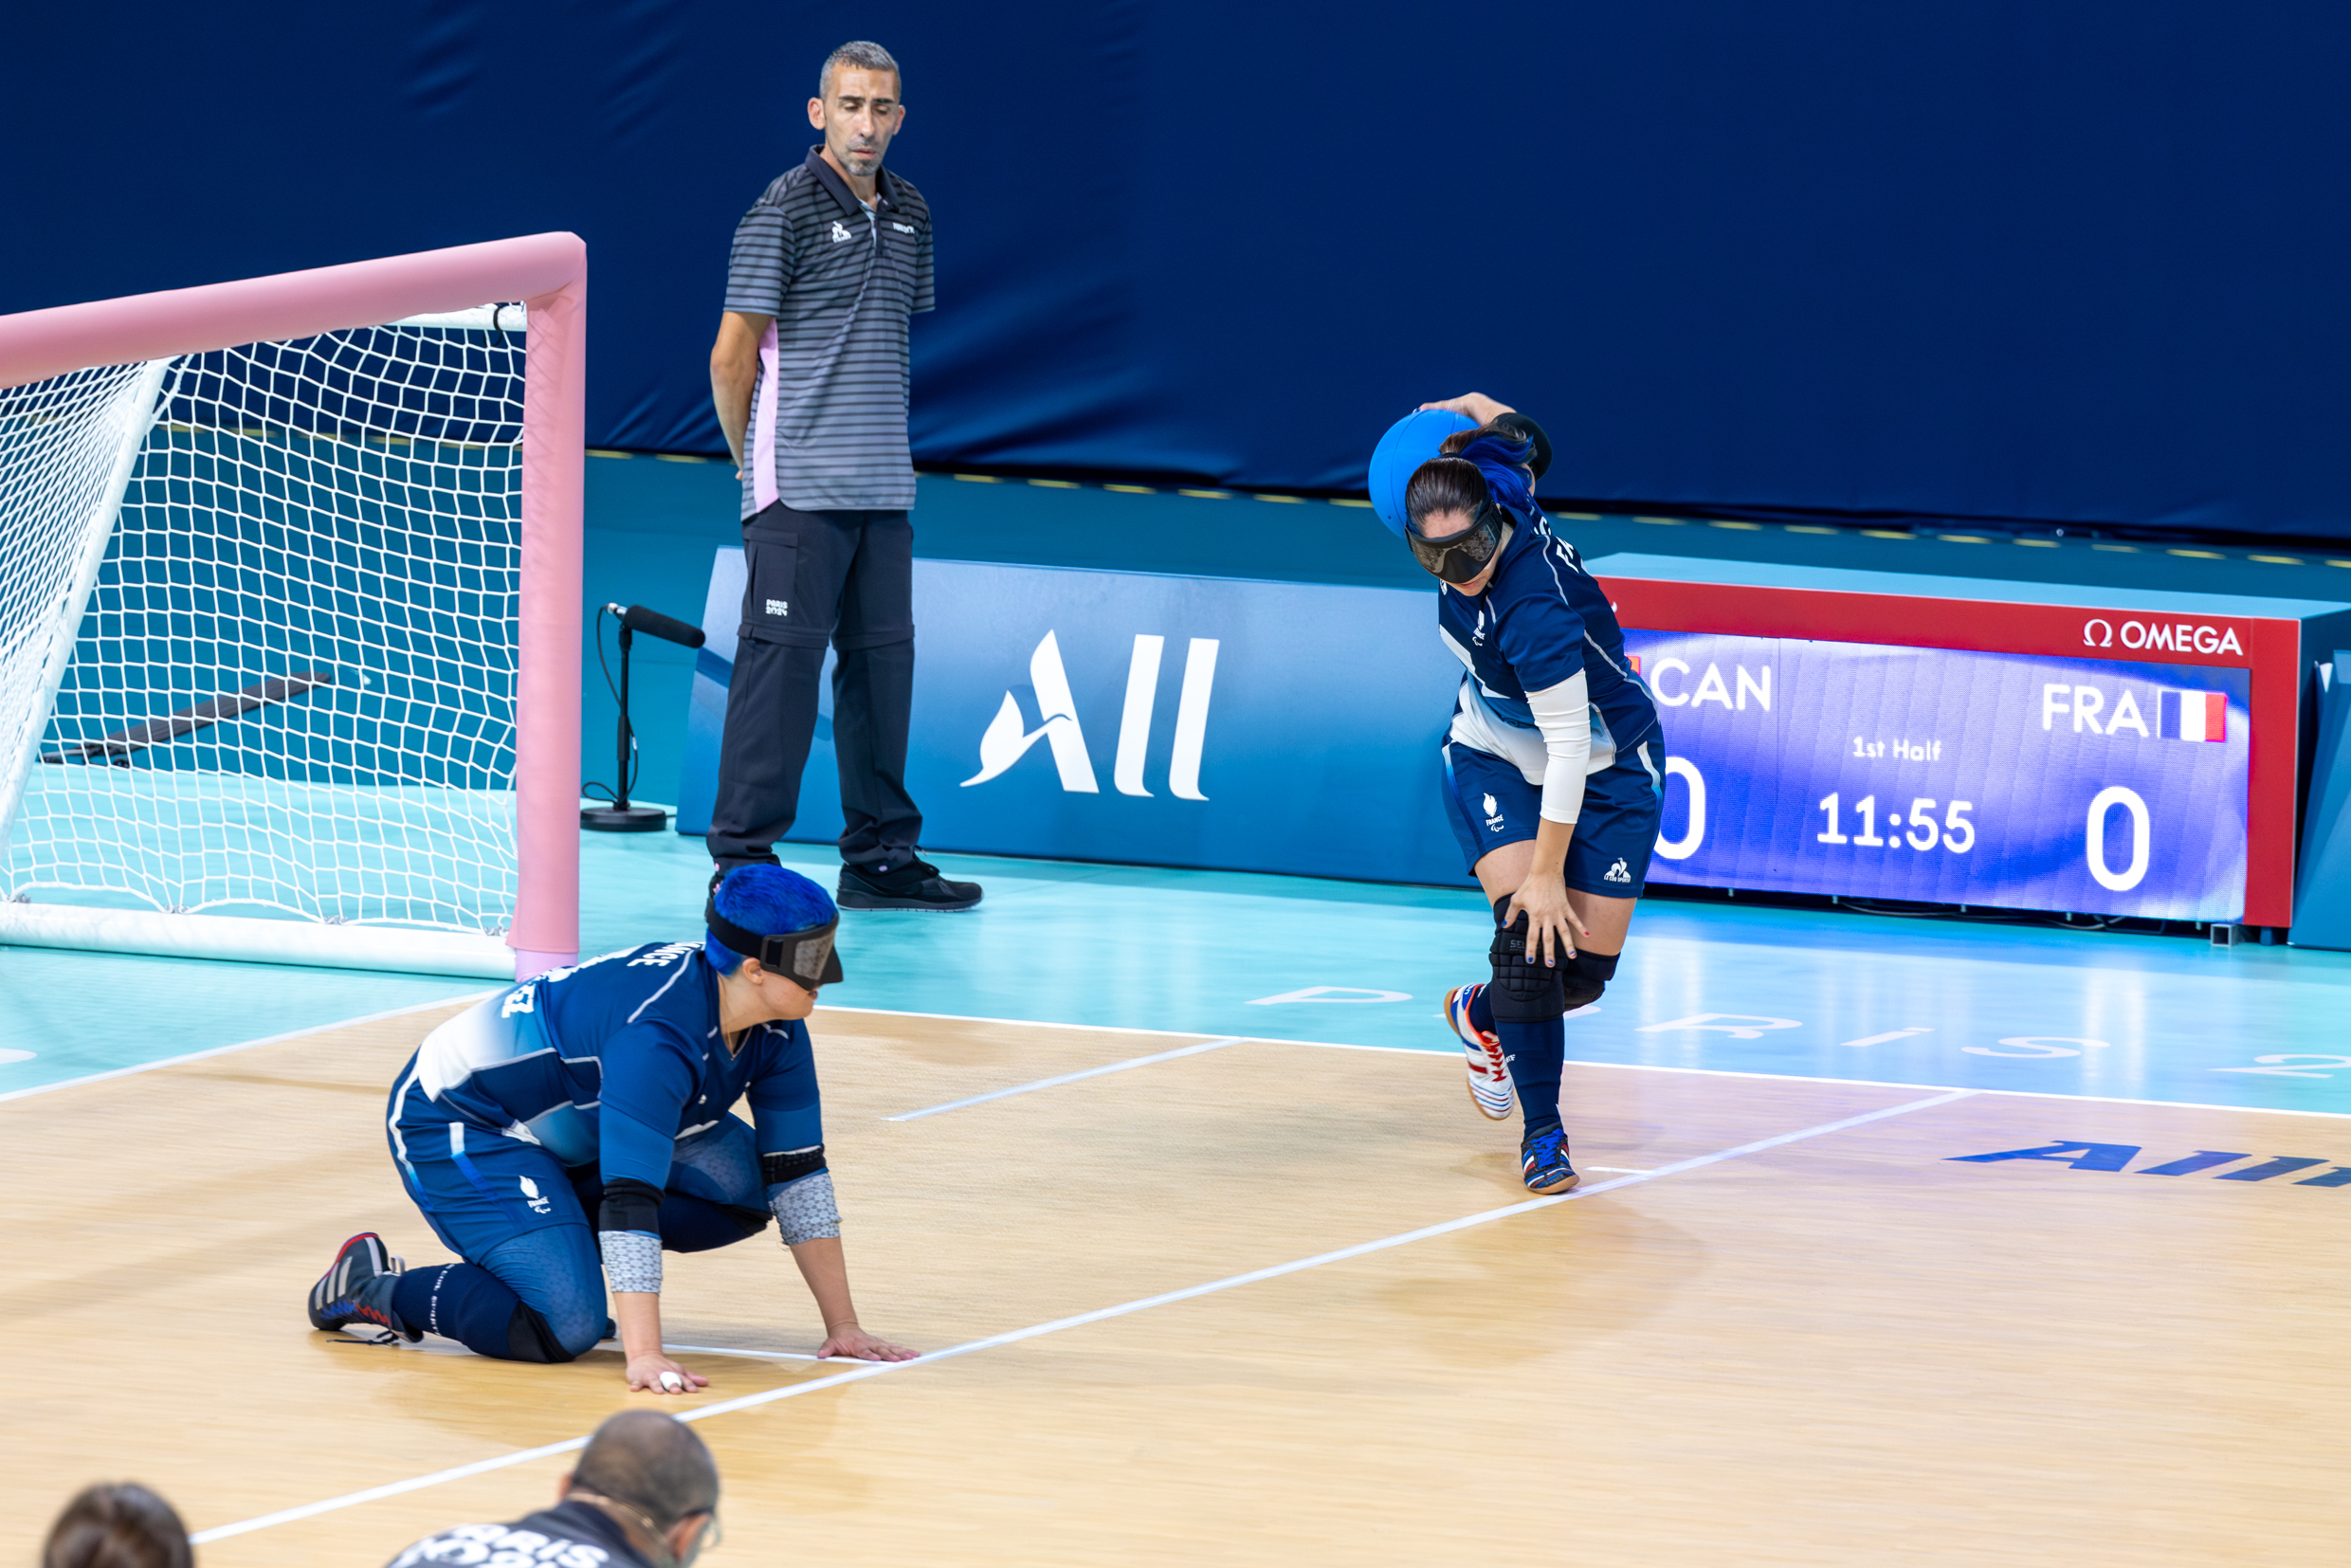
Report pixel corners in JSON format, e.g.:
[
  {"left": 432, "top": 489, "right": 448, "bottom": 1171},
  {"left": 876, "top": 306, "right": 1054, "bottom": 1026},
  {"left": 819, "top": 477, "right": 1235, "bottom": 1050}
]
[{"left": 188, "top": 1088, "right": 1979, "bottom": 1547}]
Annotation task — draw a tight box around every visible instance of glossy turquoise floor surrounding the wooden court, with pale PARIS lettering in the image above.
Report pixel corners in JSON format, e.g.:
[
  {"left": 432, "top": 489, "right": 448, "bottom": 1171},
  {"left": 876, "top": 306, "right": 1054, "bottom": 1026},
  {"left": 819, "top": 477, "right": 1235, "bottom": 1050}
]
[{"left": 0, "top": 834, "right": 2351, "bottom": 1114}]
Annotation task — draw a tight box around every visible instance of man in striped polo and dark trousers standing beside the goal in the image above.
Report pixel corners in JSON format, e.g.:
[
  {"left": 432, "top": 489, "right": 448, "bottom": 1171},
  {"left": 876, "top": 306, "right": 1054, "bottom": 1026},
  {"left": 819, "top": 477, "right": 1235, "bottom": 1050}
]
[{"left": 707, "top": 43, "right": 980, "bottom": 910}]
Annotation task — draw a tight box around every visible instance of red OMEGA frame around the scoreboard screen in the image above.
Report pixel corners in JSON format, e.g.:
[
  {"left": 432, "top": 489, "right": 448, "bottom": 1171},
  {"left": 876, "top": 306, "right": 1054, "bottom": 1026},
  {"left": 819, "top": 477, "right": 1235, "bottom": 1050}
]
[{"left": 1601, "top": 574, "right": 2302, "bottom": 926}]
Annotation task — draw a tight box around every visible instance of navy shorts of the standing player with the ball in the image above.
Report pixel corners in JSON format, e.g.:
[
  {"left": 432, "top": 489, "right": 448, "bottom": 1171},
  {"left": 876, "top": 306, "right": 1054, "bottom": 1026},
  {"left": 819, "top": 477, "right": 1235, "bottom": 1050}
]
[{"left": 1441, "top": 738, "right": 1665, "bottom": 898}]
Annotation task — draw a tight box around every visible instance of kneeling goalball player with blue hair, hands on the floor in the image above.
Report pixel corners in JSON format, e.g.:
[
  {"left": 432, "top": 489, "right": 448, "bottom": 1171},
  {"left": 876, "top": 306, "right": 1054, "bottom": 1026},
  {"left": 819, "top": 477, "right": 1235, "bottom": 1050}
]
[{"left": 310, "top": 866, "right": 915, "bottom": 1394}]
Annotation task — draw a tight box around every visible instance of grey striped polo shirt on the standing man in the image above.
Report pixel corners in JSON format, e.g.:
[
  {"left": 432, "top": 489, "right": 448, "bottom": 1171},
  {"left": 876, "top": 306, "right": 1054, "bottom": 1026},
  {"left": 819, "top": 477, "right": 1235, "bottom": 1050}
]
[{"left": 726, "top": 148, "right": 936, "bottom": 518}]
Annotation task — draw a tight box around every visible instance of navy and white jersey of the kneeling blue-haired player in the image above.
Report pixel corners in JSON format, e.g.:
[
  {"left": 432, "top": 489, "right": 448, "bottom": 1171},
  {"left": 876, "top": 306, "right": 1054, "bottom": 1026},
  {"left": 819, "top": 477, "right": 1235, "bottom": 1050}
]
[{"left": 392, "top": 942, "right": 823, "bottom": 1192}]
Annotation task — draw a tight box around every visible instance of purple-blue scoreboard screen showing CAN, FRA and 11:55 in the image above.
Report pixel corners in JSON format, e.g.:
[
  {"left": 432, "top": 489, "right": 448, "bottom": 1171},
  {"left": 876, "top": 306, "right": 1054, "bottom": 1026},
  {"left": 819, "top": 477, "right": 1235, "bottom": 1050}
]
[{"left": 1625, "top": 630, "right": 2252, "bottom": 921}]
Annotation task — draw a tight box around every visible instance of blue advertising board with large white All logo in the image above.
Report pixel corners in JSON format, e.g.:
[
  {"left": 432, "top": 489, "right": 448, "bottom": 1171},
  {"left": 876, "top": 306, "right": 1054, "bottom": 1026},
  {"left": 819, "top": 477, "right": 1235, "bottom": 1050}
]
[{"left": 677, "top": 548, "right": 1467, "bottom": 884}]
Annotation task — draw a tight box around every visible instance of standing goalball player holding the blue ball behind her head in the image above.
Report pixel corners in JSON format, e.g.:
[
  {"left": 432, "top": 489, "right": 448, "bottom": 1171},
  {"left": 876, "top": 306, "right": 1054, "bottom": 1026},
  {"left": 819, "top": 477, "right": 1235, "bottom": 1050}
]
[{"left": 1371, "top": 392, "right": 1665, "bottom": 1192}]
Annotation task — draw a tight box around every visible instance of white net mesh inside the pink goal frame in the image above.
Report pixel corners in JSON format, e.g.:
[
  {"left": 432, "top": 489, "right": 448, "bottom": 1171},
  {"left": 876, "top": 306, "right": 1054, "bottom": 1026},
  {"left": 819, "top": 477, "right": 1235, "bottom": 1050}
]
[{"left": 0, "top": 313, "right": 524, "bottom": 933}]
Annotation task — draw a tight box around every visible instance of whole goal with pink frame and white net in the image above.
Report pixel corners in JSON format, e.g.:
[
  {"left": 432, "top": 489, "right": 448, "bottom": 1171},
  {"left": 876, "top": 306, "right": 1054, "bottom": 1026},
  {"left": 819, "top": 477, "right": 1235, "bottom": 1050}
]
[{"left": 0, "top": 232, "right": 588, "bottom": 978}]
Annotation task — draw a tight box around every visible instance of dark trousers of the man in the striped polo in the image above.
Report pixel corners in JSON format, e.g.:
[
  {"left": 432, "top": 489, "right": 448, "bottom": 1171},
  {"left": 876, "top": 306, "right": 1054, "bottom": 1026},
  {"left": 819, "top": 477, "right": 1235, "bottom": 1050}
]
[{"left": 707, "top": 501, "right": 921, "bottom": 872}]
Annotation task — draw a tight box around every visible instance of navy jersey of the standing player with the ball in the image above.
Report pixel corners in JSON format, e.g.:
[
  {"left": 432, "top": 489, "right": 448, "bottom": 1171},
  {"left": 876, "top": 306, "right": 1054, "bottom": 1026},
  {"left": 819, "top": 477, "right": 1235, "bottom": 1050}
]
[{"left": 1436, "top": 513, "right": 1657, "bottom": 753}]
